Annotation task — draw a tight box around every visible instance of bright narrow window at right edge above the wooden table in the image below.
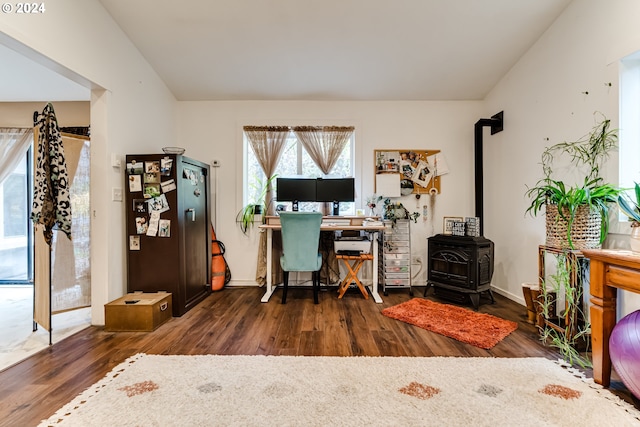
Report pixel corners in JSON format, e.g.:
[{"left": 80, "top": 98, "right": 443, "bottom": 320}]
[{"left": 619, "top": 52, "right": 640, "bottom": 221}]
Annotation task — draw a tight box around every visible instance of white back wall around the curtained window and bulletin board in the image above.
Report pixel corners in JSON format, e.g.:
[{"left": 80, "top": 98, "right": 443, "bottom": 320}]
[{"left": 177, "top": 101, "right": 481, "bottom": 286}]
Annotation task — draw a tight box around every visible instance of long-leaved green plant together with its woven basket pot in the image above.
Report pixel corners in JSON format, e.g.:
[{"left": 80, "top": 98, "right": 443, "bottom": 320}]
[{"left": 525, "top": 115, "right": 621, "bottom": 249}]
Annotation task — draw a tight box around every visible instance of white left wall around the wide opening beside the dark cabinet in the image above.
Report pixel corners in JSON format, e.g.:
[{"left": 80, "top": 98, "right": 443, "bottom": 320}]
[{"left": 0, "top": 0, "right": 176, "bottom": 324}]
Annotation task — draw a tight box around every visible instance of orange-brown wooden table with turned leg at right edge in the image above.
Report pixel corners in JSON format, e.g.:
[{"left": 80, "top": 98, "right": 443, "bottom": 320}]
[{"left": 582, "top": 249, "right": 640, "bottom": 387}]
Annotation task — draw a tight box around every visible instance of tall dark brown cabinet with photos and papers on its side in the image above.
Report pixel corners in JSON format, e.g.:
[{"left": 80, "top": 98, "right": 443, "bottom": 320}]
[{"left": 125, "top": 154, "right": 211, "bottom": 316}]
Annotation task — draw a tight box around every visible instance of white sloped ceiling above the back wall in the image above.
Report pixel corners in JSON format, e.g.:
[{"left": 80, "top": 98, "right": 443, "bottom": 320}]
[{"left": 0, "top": 0, "right": 571, "bottom": 101}]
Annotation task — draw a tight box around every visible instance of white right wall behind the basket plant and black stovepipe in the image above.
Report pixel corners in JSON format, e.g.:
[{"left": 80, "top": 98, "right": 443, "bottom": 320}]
[{"left": 484, "top": 0, "right": 640, "bottom": 315}]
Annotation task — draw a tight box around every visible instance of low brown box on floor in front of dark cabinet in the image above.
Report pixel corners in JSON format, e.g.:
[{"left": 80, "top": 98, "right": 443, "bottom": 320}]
[{"left": 104, "top": 292, "right": 172, "bottom": 332}]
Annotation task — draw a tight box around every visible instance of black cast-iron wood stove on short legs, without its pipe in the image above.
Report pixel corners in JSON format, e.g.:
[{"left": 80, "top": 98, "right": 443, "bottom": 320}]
[{"left": 424, "top": 234, "right": 494, "bottom": 310}]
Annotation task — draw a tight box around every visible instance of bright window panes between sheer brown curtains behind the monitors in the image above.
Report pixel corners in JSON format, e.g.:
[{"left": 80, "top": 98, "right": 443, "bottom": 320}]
[{"left": 244, "top": 128, "right": 355, "bottom": 215}]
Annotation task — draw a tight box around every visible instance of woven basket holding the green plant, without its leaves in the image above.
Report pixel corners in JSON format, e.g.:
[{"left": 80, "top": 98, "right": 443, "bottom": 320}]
[{"left": 546, "top": 204, "right": 602, "bottom": 250}]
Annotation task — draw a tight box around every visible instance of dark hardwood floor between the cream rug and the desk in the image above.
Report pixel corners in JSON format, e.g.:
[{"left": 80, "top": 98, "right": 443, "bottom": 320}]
[{"left": 0, "top": 287, "right": 640, "bottom": 426}]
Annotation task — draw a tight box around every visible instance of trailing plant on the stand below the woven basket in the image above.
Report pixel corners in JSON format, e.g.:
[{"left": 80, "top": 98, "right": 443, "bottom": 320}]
[{"left": 538, "top": 253, "right": 591, "bottom": 368}]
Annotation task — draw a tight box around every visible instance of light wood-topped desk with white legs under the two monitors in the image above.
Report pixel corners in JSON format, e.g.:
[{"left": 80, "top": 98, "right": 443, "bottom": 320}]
[{"left": 260, "top": 217, "right": 384, "bottom": 304}]
